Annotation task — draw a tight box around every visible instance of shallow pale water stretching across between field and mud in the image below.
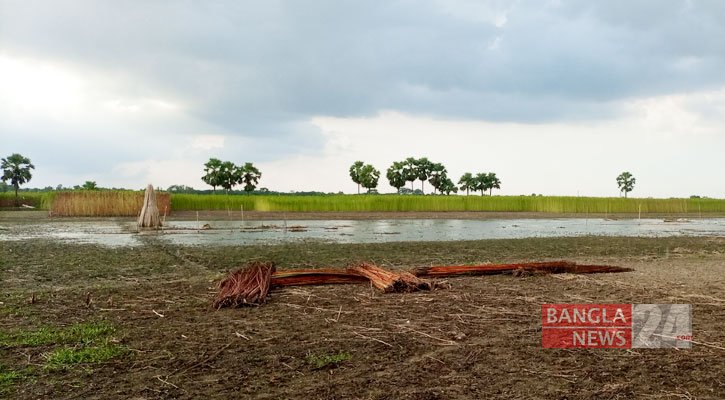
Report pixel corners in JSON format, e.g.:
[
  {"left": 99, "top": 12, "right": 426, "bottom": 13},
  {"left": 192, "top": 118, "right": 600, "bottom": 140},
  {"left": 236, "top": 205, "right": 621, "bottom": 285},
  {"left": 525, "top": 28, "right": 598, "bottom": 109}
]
[{"left": 0, "top": 218, "right": 725, "bottom": 246}]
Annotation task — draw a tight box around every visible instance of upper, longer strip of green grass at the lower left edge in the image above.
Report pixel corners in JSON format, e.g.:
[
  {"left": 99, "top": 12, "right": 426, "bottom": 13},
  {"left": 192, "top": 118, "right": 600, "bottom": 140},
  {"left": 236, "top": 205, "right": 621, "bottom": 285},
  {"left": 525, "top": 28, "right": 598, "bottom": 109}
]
[{"left": 0, "top": 321, "right": 115, "bottom": 347}]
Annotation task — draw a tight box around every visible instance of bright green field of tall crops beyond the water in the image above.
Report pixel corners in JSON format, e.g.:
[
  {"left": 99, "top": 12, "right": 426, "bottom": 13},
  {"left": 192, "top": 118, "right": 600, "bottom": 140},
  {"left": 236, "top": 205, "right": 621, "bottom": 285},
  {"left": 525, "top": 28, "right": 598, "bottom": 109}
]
[{"left": 5, "top": 192, "right": 725, "bottom": 213}]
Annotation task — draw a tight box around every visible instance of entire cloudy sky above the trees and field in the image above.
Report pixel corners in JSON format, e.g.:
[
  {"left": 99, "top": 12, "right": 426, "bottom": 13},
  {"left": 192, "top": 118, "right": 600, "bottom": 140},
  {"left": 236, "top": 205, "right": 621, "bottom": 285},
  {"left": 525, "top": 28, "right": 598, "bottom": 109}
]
[{"left": 0, "top": 0, "right": 725, "bottom": 198}]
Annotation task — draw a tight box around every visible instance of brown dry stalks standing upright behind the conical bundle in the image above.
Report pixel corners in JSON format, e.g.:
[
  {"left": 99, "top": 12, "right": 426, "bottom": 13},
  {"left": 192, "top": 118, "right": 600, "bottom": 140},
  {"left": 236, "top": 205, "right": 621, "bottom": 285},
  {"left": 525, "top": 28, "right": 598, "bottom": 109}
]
[{"left": 51, "top": 191, "right": 171, "bottom": 217}]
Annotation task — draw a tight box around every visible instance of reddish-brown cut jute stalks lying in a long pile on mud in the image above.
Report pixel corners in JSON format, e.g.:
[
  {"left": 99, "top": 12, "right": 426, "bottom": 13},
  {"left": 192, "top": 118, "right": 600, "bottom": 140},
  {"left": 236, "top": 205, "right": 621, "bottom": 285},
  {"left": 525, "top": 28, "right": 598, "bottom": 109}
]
[{"left": 213, "top": 261, "right": 632, "bottom": 309}]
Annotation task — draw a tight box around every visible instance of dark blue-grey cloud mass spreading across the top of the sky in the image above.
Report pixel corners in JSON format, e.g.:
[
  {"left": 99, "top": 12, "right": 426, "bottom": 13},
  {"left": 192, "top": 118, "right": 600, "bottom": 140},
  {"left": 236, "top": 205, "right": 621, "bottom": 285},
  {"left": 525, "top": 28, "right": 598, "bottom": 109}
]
[{"left": 0, "top": 1, "right": 725, "bottom": 142}]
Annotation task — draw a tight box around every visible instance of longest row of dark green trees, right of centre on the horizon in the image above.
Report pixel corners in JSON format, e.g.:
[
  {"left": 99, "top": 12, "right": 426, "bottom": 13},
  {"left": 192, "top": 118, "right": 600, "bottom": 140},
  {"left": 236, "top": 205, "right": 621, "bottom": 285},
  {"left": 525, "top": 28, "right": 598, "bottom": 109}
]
[{"left": 350, "top": 157, "right": 501, "bottom": 196}]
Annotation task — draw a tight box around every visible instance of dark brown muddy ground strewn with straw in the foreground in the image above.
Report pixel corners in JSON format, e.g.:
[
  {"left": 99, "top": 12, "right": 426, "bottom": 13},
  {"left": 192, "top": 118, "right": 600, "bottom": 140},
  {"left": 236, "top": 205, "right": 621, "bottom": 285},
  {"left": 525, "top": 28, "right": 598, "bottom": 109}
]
[{"left": 0, "top": 228, "right": 725, "bottom": 399}]
